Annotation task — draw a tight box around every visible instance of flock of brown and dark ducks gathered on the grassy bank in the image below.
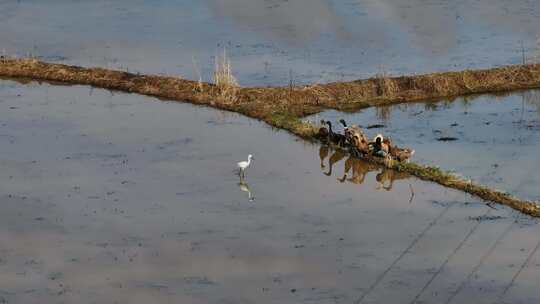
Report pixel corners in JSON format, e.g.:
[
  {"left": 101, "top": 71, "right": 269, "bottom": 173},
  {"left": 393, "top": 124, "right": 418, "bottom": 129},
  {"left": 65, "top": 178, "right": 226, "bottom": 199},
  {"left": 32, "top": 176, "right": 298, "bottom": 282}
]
[{"left": 318, "top": 119, "right": 414, "bottom": 162}]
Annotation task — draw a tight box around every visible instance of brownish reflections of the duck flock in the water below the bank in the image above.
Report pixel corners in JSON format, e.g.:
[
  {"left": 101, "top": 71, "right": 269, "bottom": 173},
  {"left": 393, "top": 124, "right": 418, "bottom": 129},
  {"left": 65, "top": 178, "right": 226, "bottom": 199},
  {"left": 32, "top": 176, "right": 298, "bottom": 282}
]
[{"left": 319, "top": 146, "right": 411, "bottom": 191}]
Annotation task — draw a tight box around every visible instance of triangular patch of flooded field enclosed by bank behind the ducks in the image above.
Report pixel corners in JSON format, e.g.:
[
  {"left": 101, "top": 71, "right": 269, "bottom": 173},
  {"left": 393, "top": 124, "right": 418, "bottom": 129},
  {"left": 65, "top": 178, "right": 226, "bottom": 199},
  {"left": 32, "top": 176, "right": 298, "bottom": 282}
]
[{"left": 310, "top": 91, "right": 540, "bottom": 201}]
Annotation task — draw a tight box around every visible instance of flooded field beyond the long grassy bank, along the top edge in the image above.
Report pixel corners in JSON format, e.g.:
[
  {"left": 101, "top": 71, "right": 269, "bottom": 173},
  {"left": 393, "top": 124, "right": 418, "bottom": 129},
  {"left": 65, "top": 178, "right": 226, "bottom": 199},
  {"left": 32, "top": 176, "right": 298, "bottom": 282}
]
[{"left": 0, "top": 0, "right": 540, "bottom": 86}]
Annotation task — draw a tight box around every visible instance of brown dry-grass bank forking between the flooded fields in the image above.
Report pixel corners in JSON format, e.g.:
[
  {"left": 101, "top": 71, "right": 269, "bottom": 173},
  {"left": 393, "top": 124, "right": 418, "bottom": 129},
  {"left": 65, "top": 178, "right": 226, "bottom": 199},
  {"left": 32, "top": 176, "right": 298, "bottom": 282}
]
[{"left": 0, "top": 58, "right": 540, "bottom": 216}]
